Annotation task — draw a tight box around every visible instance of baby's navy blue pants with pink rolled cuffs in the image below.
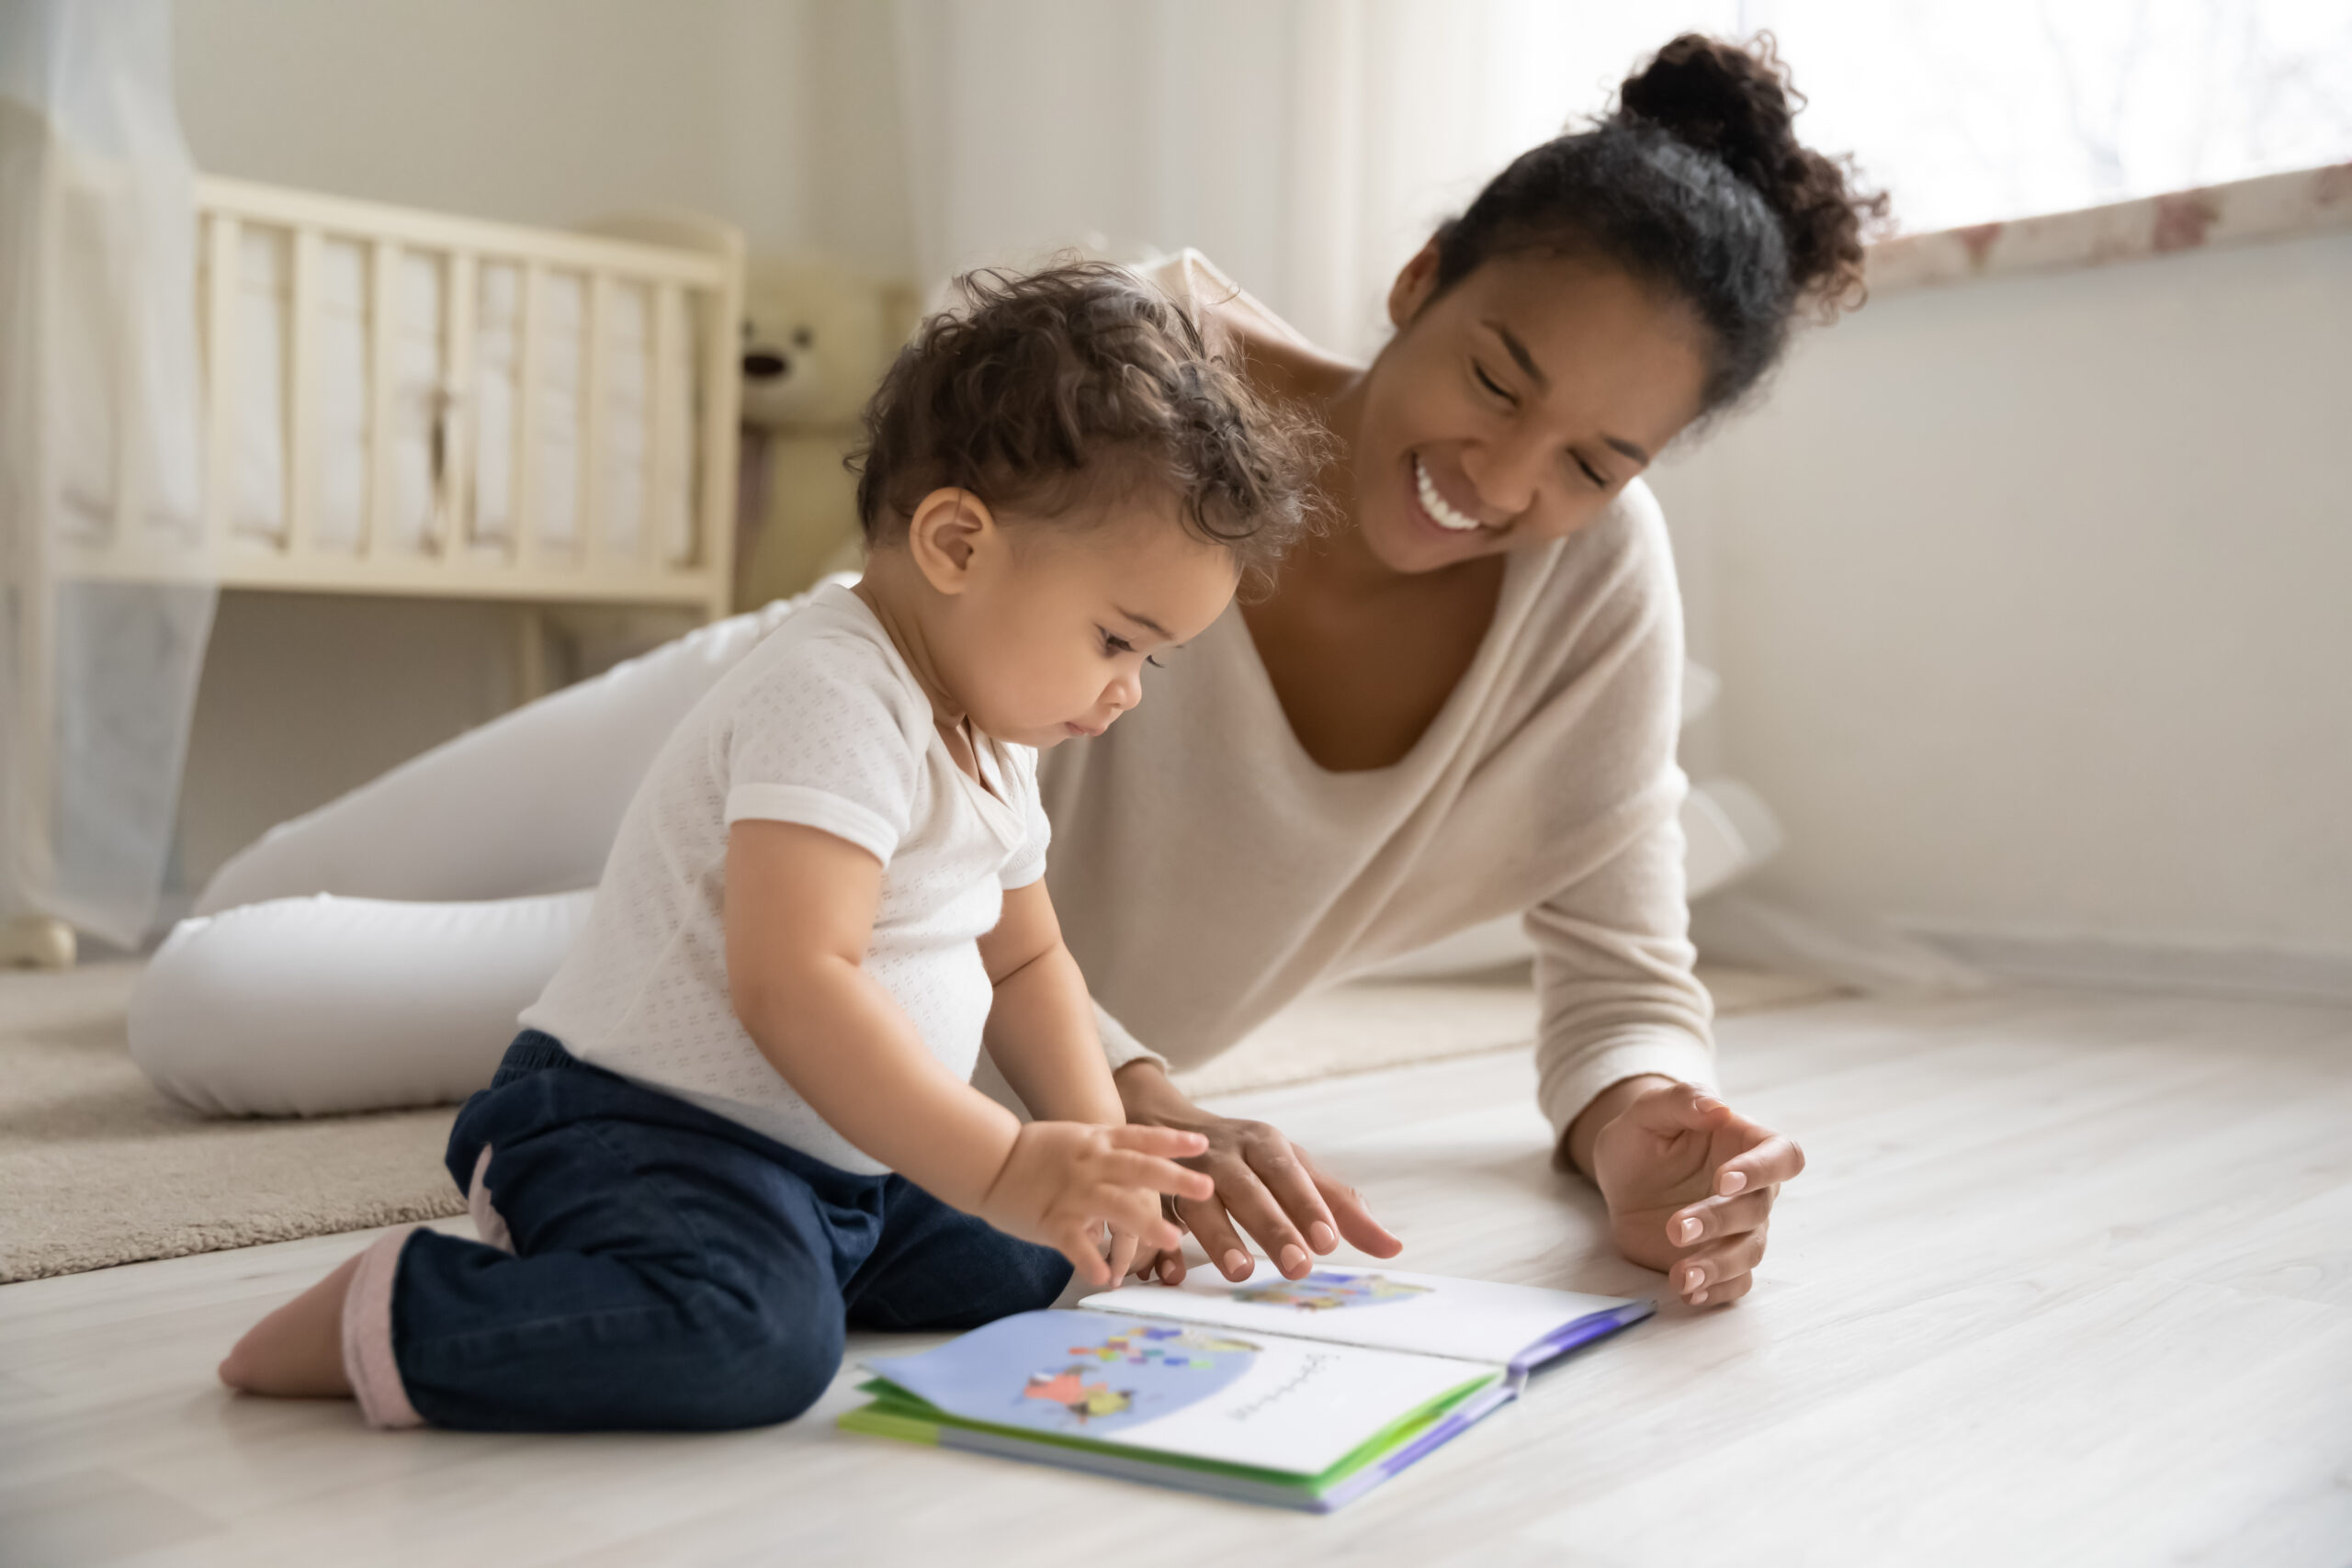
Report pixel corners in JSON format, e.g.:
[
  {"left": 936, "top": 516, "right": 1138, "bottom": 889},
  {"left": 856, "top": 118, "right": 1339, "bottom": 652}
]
[{"left": 368, "top": 1030, "right": 1070, "bottom": 1432}]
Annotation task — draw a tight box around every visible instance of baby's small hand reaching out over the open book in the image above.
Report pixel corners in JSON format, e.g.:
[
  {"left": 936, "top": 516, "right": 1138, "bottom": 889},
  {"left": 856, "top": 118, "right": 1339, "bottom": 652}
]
[{"left": 978, "top": 1122, "right": 1216, "bottom": 1286}]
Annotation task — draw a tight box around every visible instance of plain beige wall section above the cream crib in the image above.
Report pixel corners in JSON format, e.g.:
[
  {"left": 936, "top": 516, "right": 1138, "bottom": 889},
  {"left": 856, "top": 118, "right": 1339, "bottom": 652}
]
[{"left": 174, "top": 0, "right": 906, "bottom": 265}]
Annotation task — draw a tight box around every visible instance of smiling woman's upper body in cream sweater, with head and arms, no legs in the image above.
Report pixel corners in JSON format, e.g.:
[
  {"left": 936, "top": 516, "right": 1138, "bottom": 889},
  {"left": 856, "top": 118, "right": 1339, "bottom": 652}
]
[{"left": 1068, "top": 35, "right": 1884, "bottom": 1304}]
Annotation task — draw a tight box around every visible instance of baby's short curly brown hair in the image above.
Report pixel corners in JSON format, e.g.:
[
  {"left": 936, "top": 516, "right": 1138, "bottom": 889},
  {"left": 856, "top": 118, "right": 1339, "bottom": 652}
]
[{"left": 849, "top": 261, "right": 1324, "bottom": 585}]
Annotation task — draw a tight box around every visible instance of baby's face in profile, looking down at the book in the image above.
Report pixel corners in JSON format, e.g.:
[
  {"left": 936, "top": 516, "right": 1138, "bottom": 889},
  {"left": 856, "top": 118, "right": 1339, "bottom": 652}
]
[{"left": 955, "top": 501, "right": 1239, "bottom": 748}]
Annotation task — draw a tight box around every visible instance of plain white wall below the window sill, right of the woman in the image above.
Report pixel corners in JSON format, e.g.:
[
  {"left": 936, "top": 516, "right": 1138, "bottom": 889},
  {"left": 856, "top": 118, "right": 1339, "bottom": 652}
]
[{"left": 1658, "top": 235, "right": 2352, "bottom": 962}]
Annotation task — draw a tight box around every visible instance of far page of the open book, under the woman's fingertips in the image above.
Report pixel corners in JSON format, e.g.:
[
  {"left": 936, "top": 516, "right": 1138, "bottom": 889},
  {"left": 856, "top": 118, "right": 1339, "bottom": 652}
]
[{"left": 1080, "top": 1260, "right": 1646, "bottom": 1363}]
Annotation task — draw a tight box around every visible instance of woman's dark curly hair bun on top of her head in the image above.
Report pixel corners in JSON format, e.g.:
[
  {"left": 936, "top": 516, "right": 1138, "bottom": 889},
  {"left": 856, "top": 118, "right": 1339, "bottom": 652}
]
[{"left": 1613, "top": 33, "right": 1886, "bottom": 312}]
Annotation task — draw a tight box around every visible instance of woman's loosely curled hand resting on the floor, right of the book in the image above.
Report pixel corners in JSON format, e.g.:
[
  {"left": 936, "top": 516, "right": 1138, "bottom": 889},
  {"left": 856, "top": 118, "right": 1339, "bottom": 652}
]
[{"left": 1569, "top": 1077, "right": 1804, "bottom": 1307}]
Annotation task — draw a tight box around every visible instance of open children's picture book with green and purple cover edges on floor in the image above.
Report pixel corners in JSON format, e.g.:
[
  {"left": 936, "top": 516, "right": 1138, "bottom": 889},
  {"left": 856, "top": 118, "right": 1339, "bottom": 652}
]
[{"left": 842, "top": 1265, "right": 1654, "bottom": 1512}]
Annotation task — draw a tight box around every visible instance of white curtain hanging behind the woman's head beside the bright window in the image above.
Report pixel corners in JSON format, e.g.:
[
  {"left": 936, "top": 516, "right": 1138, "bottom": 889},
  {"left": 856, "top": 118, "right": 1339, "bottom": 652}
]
[{"left": 896, "top": 0, "right": 1738, "bottom": 353}]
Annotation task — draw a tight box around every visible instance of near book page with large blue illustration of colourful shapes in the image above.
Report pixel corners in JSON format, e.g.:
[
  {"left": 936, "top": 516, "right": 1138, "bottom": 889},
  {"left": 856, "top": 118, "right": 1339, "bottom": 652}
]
[{"left": 865, "top": 1312, "right": 1500, "bottom": 1476}]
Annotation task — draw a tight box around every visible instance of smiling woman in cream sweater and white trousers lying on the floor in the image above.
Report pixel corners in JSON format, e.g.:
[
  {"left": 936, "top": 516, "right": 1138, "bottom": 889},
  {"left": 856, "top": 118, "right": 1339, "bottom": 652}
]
[{"left": 131, "top": 35, "right": 1874, "bottom": 1304}]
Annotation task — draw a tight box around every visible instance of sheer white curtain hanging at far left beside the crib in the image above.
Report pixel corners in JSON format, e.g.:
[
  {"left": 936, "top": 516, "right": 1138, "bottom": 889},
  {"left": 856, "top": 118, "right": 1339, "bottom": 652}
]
[{"left": 0, "top": 0, "right": 214, "bottom": 945}]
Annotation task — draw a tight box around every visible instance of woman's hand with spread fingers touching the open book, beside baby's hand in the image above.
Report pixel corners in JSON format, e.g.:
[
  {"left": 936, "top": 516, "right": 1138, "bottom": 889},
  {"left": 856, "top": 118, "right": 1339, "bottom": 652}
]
[{"left": 1114, "top": 1060, "right": 1404, "bottom": 1286}]
